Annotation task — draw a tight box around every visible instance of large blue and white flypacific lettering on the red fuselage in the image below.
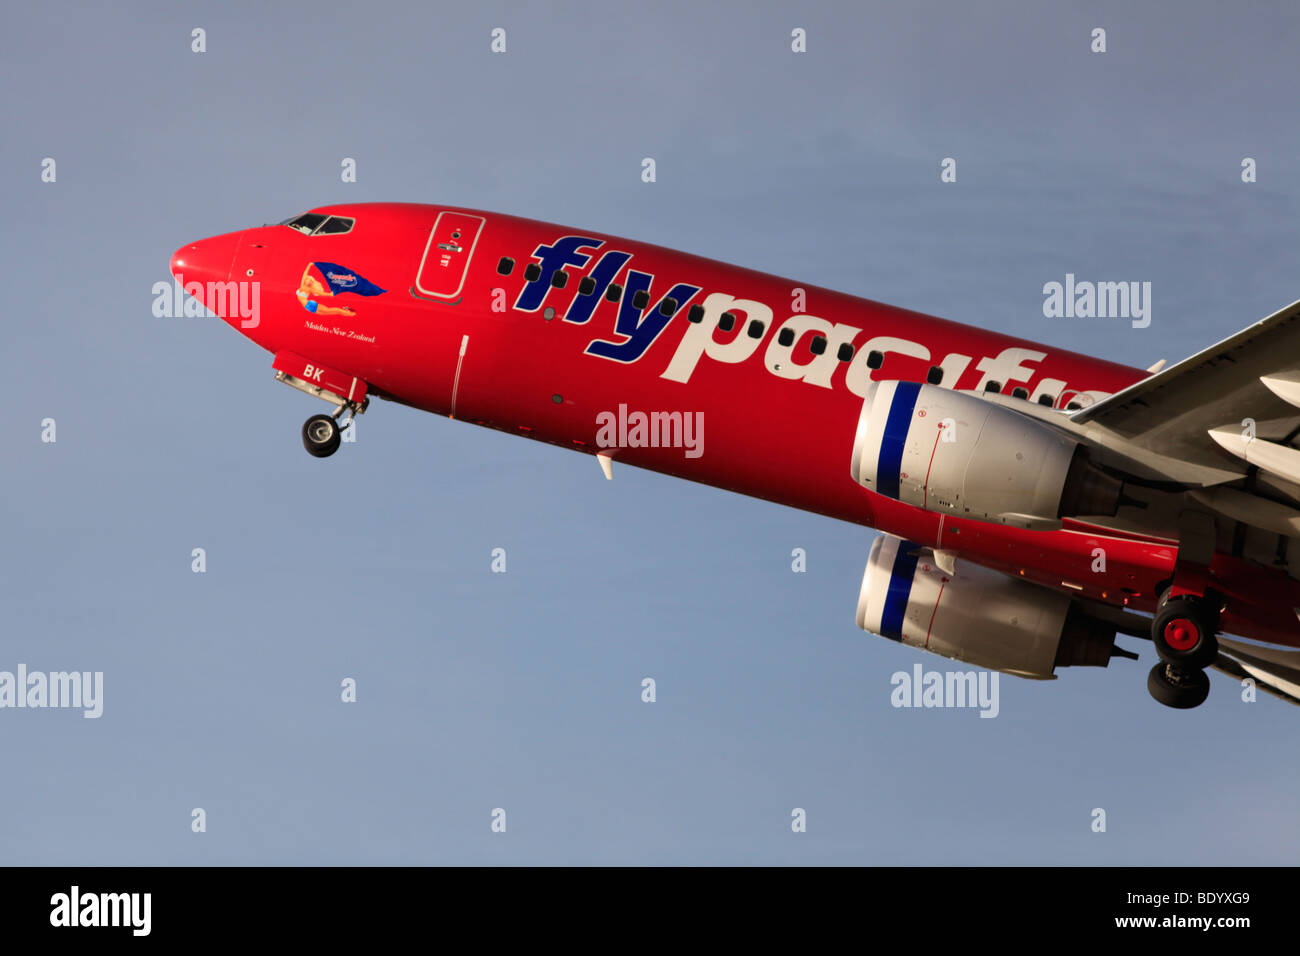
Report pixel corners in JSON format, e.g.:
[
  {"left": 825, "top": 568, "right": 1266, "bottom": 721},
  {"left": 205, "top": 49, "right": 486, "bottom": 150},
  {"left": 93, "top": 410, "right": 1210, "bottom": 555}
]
[{"left": 515, "top": 235, "right": 1110, "bottom": 406}]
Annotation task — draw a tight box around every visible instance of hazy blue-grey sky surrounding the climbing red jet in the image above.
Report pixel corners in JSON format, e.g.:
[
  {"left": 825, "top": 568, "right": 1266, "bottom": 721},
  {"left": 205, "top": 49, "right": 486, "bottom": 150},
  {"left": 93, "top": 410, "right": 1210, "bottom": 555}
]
[{"left": 0, "top": 3, "right": 1300, "bottom": 864}]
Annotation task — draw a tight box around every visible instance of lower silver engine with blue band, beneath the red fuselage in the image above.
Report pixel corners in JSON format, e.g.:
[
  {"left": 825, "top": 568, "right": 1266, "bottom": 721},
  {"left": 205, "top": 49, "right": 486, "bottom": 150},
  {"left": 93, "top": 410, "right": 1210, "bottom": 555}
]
[{"left": 858, "top": 535, "right": 1115, "bottom": 680}]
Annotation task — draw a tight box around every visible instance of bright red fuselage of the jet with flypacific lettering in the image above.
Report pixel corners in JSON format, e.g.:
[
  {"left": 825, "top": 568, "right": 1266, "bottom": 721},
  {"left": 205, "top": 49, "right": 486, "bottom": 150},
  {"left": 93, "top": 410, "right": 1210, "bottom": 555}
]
[{"left": 172, "top": 203, "right": 1300, "bottom": 646}]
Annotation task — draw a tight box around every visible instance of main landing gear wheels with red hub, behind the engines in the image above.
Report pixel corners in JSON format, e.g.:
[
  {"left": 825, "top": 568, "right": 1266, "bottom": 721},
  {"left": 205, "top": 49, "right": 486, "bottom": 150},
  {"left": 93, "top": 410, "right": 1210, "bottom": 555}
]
[{"left": 1147, "top": 588, "right": 1218, "bottom": 710}]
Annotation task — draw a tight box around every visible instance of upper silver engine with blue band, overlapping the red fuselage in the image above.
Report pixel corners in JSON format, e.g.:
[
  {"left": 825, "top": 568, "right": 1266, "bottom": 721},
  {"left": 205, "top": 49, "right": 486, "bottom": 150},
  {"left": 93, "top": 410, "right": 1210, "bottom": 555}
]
[{"left": 852, "top": 381, "right": 1123, "bottom": 529}]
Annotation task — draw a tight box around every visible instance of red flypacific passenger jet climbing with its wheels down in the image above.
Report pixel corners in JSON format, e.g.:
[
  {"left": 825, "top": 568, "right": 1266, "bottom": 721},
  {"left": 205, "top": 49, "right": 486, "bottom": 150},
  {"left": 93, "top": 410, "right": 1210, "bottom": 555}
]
[{"left": 170, "top": 203, "right": 1300, "bottom": 709}]
